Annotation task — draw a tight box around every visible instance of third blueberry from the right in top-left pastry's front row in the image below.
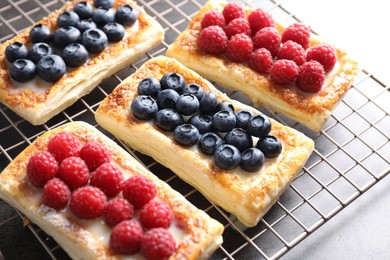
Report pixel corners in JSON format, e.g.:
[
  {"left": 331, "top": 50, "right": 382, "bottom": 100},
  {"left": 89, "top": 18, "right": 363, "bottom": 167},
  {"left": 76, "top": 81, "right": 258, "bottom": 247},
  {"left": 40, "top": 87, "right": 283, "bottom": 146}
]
[{"left": 81, "top": 29, "right": 108, "bottom": 53}]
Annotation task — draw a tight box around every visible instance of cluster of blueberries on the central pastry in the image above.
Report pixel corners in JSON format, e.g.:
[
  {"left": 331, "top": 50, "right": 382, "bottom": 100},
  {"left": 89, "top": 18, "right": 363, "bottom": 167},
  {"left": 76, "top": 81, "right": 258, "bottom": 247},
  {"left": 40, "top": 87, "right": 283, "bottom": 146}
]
[{"left": 131, "top": 73, "right": 282, "bottom": 172}]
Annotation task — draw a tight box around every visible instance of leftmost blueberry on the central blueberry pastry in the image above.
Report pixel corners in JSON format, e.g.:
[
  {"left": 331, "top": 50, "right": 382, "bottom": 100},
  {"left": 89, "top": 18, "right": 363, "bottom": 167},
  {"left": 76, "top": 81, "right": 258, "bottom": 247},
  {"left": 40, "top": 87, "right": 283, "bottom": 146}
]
[{"left": 131, "top": 95, "right": 158, "bottom": 120}]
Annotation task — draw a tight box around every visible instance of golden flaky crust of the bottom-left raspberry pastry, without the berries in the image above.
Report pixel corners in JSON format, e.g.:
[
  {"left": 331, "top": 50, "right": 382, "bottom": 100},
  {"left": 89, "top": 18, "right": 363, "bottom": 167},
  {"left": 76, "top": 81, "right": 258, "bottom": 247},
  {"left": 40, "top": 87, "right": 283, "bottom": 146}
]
[{"left": 0, "top": 122, "right": 223, "bottom": 259}]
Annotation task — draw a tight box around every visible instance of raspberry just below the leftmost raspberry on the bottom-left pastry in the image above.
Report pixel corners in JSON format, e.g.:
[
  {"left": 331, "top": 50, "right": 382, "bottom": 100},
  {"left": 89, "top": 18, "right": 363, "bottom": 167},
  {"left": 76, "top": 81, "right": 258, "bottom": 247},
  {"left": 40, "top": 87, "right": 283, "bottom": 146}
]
[{"left": 42, "top": 178, "right": 70, "bottom": 209}]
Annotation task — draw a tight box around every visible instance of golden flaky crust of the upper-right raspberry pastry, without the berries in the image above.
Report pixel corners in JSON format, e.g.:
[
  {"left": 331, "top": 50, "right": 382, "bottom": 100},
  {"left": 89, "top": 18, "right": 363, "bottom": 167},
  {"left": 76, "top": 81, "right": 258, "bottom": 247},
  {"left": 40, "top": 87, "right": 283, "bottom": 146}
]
[{"left": 166, "top": 0, "right": 359, "bottom": 131}]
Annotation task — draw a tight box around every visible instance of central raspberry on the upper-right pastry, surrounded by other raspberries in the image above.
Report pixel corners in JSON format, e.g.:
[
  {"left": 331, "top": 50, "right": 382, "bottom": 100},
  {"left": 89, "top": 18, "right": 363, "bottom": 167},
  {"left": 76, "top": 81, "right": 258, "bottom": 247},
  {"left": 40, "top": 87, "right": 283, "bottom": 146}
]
[{"left": 253, "top": 27, "right": 280, "bottom": 57}]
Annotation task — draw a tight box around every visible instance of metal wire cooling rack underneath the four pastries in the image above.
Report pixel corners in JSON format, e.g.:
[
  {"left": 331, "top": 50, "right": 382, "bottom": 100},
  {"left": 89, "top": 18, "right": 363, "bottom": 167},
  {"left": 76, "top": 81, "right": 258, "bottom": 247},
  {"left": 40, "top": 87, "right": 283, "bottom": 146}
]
[{"left": 0, "top": 0, "right": 390, "bottom": 259}]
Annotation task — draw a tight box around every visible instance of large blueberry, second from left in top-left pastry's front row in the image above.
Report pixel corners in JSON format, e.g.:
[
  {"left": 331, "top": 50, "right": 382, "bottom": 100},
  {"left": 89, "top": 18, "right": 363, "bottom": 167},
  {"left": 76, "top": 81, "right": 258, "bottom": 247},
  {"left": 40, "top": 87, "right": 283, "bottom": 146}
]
[{"left": 37, "top": 55, "right": 66, "bottom": 82}]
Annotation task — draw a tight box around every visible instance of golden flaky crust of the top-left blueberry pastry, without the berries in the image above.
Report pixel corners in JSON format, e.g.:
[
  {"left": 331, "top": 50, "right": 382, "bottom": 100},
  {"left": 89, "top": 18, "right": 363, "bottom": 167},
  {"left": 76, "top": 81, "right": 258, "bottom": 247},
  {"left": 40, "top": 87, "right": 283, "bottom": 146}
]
[{"left": 0, "top": 0, "right": 164, "bottom": 125}]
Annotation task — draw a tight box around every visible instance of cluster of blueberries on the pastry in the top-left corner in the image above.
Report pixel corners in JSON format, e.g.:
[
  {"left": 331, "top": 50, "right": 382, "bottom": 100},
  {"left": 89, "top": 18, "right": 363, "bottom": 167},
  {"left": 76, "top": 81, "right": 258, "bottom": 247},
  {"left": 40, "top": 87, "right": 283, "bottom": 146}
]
[{"left": 5, "top": 0, "right": 138, "bottom": 82}]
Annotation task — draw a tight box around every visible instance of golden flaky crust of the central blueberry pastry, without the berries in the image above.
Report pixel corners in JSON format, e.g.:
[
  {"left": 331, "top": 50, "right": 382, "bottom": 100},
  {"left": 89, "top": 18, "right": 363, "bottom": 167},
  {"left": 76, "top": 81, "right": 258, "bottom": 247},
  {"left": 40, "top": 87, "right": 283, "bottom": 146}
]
[{"left": 95, "top": 57, "right": 314, "bottom": 226}]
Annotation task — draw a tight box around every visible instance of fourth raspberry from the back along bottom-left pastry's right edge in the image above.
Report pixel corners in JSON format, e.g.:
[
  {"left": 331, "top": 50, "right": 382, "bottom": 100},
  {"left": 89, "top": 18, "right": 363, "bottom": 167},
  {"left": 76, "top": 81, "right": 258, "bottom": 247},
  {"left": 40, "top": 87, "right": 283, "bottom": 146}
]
[{"left": 122, "top": 175, "right": 157, "bottom": 209}]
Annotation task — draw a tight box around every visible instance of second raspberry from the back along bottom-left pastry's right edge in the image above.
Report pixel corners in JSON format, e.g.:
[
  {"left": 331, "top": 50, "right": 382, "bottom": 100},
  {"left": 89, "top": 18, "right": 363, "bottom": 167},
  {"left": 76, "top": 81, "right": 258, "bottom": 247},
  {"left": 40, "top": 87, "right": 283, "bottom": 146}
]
[{"left": 80, "top": 141, "right": 111, "bottom": 172}]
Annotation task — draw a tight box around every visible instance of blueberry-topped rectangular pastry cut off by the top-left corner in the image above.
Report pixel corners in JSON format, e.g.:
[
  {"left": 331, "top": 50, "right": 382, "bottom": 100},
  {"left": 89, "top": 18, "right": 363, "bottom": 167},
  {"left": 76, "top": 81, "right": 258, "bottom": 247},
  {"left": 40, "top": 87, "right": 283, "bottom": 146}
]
[{"left": 0, "top": 0, "right": 164, "bottom": 125}]
